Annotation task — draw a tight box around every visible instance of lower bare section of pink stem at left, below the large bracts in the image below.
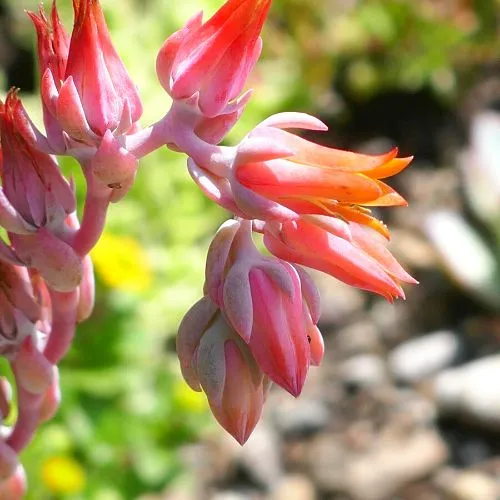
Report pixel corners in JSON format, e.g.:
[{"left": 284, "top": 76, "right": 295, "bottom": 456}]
[{"left": 43, "top": 290, "right": 78, "bottom": 365}]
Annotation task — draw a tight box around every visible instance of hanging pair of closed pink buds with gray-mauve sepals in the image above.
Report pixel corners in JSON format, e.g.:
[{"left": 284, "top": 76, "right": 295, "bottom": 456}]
[{"left": 177, "top": 220, "right": 323, "bottom": 444}]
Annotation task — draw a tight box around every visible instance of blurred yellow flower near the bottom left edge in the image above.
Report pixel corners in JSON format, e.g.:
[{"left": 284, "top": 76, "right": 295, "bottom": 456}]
[{"left": 42, "top": 456, "right": 86, "bottom": 495}]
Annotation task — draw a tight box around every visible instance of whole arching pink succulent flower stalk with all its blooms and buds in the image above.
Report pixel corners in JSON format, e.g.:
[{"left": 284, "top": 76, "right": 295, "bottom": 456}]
[{"left": 0, "top": 0, "right": 415, "bottom": 492}]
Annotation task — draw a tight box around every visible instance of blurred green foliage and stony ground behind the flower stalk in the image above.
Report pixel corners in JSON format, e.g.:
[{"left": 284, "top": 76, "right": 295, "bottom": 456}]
[{"left": 0, "top": 0, "right": 500, "bottom": 500}]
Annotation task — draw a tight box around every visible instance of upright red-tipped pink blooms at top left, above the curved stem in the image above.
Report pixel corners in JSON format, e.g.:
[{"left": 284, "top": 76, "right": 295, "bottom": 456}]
[{"left": 29, "top": 0, "right": 142, "bottom": 153}]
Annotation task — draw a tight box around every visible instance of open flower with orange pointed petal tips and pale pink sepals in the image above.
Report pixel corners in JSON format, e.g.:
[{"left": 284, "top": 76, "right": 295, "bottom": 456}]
[{"left": 188, "top": 113, "right": 411, "bottom": 227}]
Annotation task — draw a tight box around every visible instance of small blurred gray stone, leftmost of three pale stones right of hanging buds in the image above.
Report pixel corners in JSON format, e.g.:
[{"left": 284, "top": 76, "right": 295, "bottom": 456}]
[{"left": 339, "top": 354, "right": 388, "bottom": 389}]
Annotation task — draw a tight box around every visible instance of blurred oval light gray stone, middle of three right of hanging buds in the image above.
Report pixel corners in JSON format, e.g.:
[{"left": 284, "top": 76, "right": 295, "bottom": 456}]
[{"left": 388, "top": 330, "right": 461, "bottom": 383}]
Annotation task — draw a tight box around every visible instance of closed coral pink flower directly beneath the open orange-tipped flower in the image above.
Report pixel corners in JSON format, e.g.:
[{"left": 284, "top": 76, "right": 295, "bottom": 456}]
[{"left": 264, "top": 215, "right": 416, "bottom": 301}]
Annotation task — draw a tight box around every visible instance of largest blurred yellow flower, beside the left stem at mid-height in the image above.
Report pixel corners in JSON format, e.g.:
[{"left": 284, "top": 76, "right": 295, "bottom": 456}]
[{"left": 91, "top": 233, "right": 153, "bottom": 292}]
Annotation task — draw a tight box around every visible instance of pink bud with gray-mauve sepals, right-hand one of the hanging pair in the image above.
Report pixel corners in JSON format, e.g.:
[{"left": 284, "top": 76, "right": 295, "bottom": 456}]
[{"left": 205, "top": 220, "right": 322, "bottom": 396}]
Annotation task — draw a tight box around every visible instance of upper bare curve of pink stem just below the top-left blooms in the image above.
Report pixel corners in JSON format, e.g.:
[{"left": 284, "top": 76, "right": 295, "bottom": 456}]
[{"left": 70, "top": 164, "right": 113, "bottom": 257}]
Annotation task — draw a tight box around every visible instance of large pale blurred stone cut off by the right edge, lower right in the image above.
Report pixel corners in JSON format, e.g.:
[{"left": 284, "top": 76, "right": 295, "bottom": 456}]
[{"left": 433, "top": 354, "right": 500, "bottom": 429}]
